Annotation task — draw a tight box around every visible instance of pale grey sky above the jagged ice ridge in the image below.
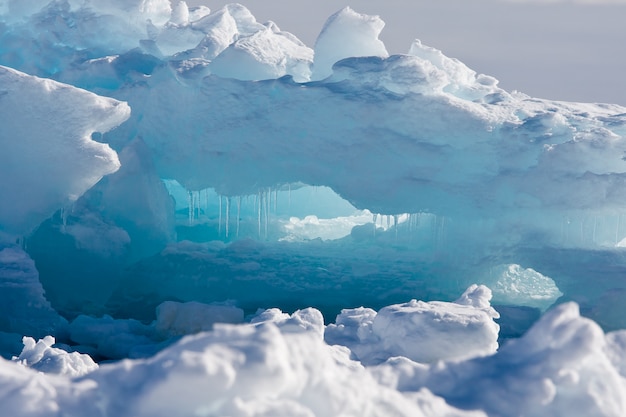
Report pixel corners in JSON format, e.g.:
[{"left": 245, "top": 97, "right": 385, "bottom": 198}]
[{"left": 184, "top": 0, "right": 626, "bottom": 105}]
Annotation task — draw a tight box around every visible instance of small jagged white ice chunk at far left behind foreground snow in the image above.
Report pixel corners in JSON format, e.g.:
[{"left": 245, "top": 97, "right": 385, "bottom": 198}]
[{"left": 13, "top": 336, "right": 98, "bottom": 377}]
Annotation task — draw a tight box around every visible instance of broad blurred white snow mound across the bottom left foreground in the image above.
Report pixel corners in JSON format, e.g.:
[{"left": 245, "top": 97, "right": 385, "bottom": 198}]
[{"left": 0, "top": 316, "right": 484, "bottom": 417}]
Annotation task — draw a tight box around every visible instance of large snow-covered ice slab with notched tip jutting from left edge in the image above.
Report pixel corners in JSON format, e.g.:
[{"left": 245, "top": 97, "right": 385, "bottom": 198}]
[{"left": 0, "top": 67, "right": 130, "bottom": 235}]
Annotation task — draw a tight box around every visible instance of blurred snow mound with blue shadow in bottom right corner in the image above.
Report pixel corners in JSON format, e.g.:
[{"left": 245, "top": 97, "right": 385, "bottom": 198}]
[{"left": 374, "top": 303, "right": 626, "bottom": 417}]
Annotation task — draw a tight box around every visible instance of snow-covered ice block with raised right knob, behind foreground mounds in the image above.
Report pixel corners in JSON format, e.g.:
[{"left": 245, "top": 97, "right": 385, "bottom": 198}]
[{"left": 325, "top": 285, "right": 499, "bottom": 364}]
